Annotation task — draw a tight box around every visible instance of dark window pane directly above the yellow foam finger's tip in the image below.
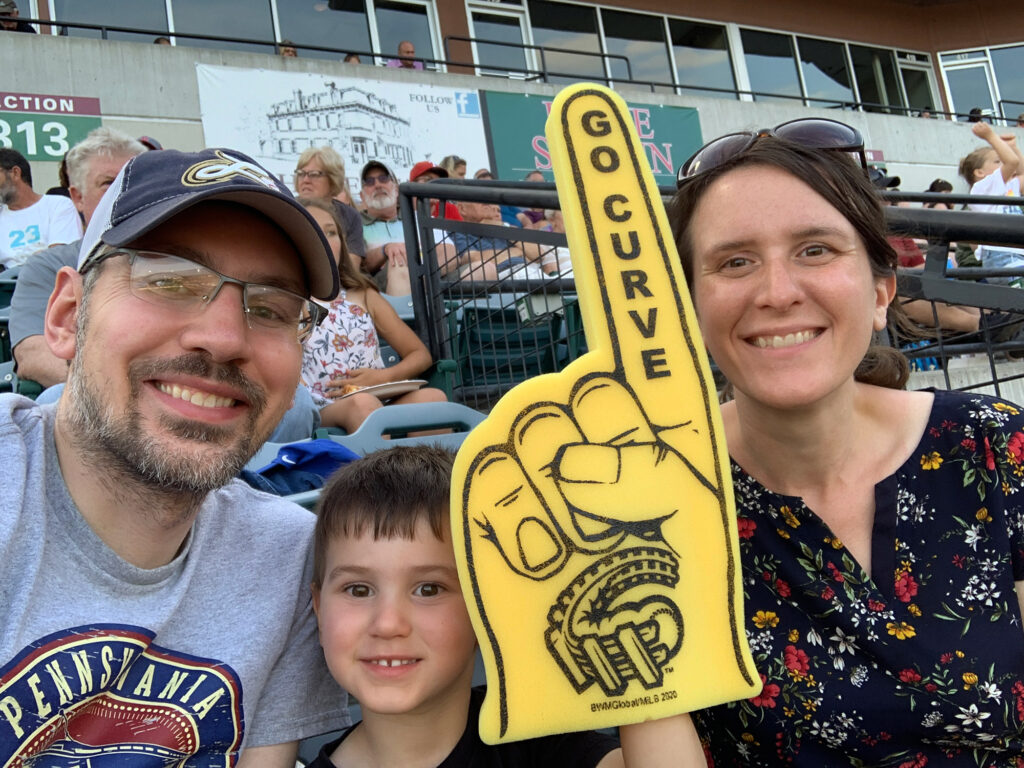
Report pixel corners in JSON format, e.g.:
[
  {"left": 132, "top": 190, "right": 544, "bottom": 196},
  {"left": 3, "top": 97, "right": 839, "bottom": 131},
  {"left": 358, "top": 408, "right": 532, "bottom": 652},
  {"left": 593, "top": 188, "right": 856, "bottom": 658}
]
[{"left": 528, "top": 0, "right": 605, "bottom": 83}]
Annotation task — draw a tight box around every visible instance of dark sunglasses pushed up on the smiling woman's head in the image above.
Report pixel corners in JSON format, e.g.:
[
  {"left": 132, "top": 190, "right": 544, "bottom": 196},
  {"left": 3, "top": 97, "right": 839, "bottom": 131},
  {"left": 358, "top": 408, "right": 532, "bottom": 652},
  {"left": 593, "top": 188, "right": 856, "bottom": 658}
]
[{"left": 676, "top": 118, "right": 867, "bottom": 186}]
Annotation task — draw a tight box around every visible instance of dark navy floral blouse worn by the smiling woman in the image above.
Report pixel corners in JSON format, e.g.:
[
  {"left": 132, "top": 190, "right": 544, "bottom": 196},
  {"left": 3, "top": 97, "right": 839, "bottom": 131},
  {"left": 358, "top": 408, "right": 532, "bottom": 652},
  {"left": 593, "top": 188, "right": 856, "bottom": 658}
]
[{"left": 694, "top": 391, "right": 1024, "bottom": 768}]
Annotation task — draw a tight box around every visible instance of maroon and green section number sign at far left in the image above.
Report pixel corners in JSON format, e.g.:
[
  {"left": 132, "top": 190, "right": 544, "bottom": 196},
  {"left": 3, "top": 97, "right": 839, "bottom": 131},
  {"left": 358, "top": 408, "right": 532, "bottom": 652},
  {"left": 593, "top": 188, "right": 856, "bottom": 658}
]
[{"left": 0, "top": 92, "right": 100, "bottom": 163}]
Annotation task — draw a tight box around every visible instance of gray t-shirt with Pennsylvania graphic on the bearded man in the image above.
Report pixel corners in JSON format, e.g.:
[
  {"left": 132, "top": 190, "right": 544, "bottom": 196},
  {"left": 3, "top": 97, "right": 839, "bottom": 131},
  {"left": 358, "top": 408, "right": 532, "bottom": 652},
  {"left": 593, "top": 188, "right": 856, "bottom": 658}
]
[{"left": 0, "top": 394, "right": 348, "bottom": 768}]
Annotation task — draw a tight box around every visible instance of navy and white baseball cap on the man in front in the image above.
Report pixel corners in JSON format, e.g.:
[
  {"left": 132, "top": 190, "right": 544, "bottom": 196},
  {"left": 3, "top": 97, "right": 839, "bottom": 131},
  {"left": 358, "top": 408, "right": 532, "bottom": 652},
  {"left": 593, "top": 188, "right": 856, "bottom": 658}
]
[{"left": 78, "top": 148, "right": 338, "bottom": 301}]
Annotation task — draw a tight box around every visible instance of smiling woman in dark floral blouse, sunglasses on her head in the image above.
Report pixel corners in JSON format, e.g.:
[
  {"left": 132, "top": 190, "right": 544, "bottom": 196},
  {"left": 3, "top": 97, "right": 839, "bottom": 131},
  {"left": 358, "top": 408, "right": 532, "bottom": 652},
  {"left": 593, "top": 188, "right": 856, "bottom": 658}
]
[{"left": 669, "top": 119, "right": 1024, "bottom": 767}]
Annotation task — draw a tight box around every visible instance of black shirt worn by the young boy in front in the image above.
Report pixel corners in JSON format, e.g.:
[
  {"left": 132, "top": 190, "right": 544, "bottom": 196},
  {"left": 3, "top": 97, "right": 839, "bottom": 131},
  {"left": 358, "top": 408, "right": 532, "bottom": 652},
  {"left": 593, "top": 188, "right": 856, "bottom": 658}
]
[{"left": 306, "top": 687, "right": 618, "bottom": 768}]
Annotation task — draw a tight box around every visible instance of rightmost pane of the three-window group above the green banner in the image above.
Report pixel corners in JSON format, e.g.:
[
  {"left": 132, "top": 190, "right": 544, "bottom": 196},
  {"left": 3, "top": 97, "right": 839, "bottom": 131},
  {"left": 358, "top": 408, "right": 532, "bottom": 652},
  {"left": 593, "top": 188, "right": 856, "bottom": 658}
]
[{"left": 669, "top": 18, "right": 736, "bottom": 98}]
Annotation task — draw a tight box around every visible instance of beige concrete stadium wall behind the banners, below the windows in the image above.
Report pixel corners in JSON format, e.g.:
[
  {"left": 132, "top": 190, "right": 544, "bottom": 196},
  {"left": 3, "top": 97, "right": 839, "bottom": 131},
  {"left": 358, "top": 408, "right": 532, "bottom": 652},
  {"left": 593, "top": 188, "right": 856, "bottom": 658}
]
[{"left": 0, "top": 33, "right": 1024, "bottom": 190}]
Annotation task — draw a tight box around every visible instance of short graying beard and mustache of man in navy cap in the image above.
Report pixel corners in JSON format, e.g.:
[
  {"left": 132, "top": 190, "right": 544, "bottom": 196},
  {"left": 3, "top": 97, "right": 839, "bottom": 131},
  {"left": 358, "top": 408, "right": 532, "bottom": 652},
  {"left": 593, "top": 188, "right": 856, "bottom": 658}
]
[{"left": 63, "top": 327, "right": 272, "bottom": 498}]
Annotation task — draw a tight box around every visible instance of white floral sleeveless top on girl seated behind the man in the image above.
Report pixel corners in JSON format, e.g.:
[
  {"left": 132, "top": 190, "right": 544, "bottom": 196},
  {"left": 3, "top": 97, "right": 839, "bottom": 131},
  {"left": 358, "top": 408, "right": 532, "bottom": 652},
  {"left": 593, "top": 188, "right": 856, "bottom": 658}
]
[{"left": 302, "top": 290, "right": 384, "bottom": 408}]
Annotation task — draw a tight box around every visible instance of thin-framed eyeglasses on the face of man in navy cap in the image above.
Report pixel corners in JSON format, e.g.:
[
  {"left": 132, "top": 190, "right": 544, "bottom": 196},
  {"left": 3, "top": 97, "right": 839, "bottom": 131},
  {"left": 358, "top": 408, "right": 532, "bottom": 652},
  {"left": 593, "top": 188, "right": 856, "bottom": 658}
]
[{"left": 79, "top": 248, "right": 327, "bottom": 343}]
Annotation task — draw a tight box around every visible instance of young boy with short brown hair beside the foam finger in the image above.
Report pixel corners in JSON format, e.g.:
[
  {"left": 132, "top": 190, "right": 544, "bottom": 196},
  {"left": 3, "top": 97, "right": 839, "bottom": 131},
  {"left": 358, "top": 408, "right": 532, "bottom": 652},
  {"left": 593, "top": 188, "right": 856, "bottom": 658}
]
[{"left": 310, "top": 445, "right": 622, "bottom": 768}]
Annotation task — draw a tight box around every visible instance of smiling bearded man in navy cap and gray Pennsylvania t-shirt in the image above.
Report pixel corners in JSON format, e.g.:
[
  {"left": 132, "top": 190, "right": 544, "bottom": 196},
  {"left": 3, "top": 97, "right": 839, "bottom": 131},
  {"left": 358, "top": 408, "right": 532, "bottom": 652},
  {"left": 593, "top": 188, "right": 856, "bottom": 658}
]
[{"left": 0, "top": 150, "right": 347, "bottom": 768}]
